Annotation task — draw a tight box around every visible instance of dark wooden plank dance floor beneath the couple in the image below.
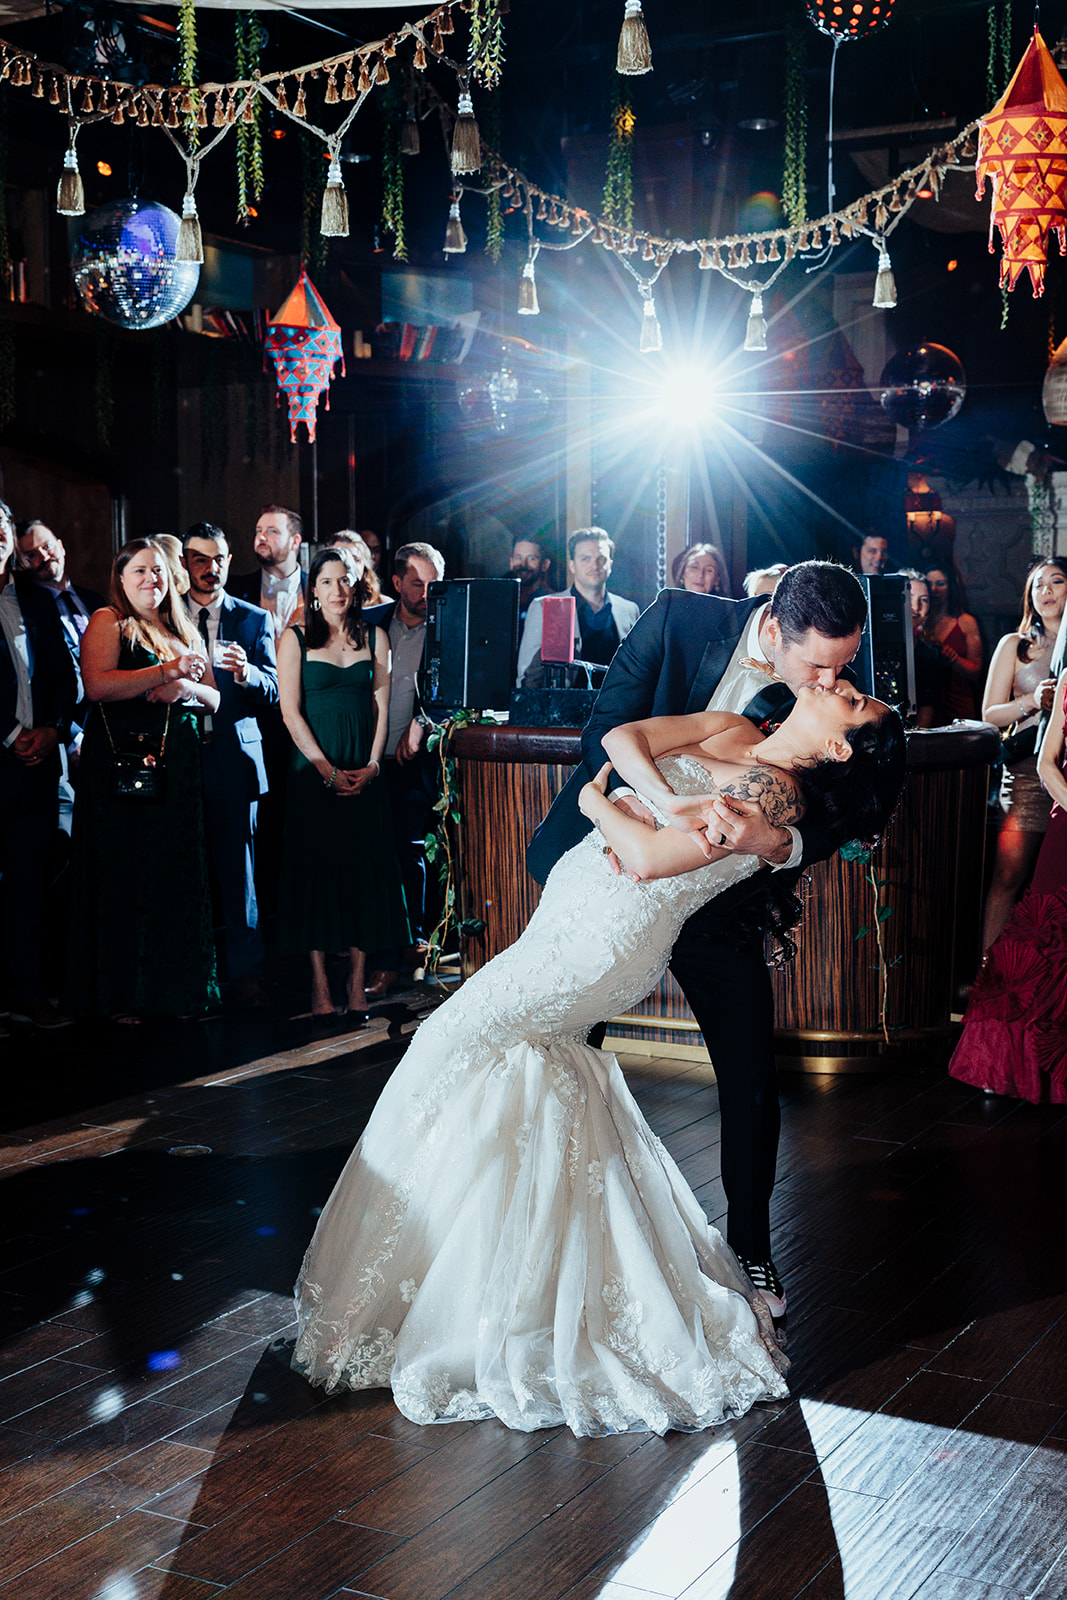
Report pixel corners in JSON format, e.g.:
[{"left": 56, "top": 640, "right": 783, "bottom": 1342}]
[{"left": 0, "top": 994, "right": 1067, "bottom": 1600}]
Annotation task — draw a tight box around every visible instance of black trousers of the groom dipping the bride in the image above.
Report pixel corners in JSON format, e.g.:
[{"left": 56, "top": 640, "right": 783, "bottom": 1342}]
[{"left": 670, "top": 912, "right": 782, "bottom": 1261}]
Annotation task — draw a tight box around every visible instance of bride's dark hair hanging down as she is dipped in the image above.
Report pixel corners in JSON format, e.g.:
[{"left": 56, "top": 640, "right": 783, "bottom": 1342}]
[{"left": 795, "top": 709, "right": 907, "bottom": 850}]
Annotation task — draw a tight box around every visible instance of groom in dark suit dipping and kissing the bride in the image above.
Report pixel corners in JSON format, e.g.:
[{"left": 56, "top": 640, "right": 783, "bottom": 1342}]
[{"left": 526, "top": 562, "right": 867, "bottom": 1317}]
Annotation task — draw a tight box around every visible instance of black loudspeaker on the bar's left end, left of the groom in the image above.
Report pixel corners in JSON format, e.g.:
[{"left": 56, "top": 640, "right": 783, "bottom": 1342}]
[{"left": 422, "top": 578, "right": 518, "bottom": 710}]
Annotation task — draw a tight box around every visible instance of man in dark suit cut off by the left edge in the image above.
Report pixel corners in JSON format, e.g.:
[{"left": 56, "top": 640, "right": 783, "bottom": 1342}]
[{"left": 0, "top": 501, "right": 78, "bottom": 1029}]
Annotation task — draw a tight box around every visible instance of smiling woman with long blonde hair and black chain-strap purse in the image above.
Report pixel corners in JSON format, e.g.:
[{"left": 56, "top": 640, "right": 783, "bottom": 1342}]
[{"left": 67, "top": 539, "right": 219, "bottom": 1022}]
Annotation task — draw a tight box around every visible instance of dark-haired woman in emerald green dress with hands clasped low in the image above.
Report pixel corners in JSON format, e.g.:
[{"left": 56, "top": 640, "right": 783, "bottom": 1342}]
[{"left": 278, "top": 549, "right": 411, "bottom": 1024}]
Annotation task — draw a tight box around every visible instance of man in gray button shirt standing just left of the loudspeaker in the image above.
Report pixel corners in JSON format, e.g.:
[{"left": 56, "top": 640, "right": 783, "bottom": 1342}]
[{"left": 366, "top": 544, "right": 445, "bottom": 998}]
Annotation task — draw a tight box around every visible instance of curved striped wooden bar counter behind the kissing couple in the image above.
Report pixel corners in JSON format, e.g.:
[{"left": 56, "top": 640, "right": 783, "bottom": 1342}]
[{"left": 454, "top": 722, "right": 998, "bottom": 1072}]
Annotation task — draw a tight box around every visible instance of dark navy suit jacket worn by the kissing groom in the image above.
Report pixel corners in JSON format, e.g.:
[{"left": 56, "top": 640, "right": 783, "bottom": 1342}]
[{"left": 526, "top": 589, "right": 837, "bottom": 917}]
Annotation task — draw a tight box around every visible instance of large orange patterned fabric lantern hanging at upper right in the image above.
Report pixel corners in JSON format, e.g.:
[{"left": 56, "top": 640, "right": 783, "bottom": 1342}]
[{"left": 974, "top": 29, "right": 1067, "bottom": 296}]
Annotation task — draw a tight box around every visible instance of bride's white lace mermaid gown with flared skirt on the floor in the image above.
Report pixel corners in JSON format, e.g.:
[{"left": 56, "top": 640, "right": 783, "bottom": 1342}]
[{"left": 293, "top": 757, "right": 787, "bottom": 1435}]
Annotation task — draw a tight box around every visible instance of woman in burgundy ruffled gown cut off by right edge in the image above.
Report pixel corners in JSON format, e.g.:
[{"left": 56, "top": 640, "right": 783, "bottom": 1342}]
[{"left": 949, "top": 672, "right": 1067, "bottom": 1106}]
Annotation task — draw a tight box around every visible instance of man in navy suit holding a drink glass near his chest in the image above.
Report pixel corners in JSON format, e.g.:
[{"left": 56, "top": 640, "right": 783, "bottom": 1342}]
[{"left": 182, "top": 522, "right": 278, "bottom": 1006}]
